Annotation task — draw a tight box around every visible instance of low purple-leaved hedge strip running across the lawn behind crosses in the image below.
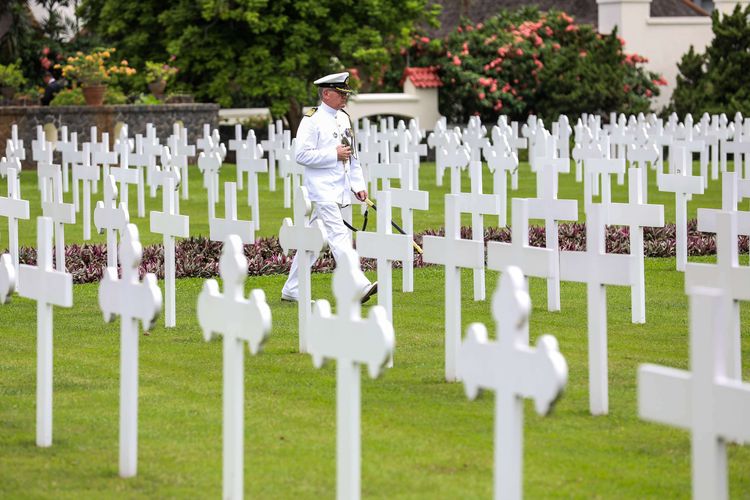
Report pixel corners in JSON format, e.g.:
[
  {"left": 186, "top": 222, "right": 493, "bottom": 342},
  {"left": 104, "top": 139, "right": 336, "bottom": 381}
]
[{"left": 11, "top": 220, "right": 750, "bottom": 283}]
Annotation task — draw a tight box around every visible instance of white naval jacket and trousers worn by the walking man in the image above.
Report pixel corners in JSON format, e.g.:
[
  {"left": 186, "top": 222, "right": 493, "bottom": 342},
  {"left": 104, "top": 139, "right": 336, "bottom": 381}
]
[{"left": 281, "top": 99, "right": 370, "bottom": 298}]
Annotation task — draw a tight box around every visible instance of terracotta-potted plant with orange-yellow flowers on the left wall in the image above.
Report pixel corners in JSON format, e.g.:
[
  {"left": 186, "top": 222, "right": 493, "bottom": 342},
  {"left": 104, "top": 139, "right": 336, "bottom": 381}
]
[{"left": 55, "top": 48, "right": 136, "bottom": 106}]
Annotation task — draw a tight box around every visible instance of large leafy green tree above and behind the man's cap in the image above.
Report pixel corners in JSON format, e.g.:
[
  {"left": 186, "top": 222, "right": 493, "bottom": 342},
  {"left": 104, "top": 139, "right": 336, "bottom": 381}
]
[{"left": 80, "top": 0, "right": 439, "bottom": 130}]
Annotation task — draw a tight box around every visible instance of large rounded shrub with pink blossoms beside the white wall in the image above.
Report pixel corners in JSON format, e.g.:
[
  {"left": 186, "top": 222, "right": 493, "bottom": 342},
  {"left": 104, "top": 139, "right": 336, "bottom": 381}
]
[{"left": 390, "top": 7, "right": 666, "bottom": 123}]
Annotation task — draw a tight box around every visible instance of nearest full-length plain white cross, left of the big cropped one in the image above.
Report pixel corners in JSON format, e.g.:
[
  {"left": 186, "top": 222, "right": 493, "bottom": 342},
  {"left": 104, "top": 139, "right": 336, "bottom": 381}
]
[{"left": 560, "top": 203, "right": 633, "bottom": 415}]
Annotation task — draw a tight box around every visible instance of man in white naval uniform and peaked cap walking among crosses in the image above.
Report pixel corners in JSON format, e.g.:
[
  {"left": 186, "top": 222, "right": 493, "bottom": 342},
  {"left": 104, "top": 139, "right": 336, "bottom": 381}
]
[{"left": 281, "top": 72, "right": 378, "bottom": 303}]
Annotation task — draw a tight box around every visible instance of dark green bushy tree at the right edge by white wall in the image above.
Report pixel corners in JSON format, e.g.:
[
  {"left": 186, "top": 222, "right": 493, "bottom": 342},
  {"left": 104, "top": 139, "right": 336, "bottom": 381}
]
[{"left": 668, "top": 5, "right": 750, "bottom": 117}]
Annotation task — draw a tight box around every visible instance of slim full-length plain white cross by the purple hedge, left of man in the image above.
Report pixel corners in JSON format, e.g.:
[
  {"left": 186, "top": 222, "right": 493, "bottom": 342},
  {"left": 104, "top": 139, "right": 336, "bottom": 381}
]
[{"left": 151, "top": 176, "right": 190, "bottom": 328}]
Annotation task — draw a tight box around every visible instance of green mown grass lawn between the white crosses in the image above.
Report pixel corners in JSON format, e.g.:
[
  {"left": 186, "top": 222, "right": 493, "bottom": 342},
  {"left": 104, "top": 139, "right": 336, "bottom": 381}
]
[{"left": 0, "top": 164, "right": 750, "bottom": 498}]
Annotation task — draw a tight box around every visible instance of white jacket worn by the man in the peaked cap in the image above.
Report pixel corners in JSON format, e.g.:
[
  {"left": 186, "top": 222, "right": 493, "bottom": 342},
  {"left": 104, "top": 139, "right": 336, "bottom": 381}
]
[{"left": 296, "top": 103, "right": 366, "bottom": 205}]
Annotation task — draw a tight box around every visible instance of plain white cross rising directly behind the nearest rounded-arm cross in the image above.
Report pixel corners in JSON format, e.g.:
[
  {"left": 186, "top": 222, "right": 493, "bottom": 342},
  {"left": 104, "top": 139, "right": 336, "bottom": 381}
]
[{"left": 487, "top": 198, "right": 559, "bottom": 280}]
